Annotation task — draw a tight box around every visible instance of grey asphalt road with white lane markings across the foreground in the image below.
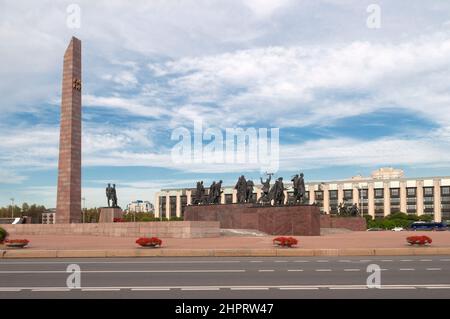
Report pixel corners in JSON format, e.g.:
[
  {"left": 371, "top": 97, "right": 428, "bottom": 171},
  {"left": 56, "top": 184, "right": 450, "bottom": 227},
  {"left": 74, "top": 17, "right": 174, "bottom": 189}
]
[{"left": 0, "top": 256, "right": 450, "bottom": 299}]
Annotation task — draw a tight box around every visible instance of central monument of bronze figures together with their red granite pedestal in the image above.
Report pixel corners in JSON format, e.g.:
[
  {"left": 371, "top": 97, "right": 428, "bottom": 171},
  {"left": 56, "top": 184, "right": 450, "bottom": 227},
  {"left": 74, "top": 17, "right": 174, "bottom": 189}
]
[{"left": 184, "top": 173, "right": 320, "bottom": 236}]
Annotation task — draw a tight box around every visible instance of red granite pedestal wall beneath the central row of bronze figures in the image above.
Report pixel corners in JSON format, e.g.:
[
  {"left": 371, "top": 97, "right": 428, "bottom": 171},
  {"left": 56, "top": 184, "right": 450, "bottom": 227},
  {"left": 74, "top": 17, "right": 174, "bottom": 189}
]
[{"left": 184, "top": 204, "right": 320, "bottom": 236}]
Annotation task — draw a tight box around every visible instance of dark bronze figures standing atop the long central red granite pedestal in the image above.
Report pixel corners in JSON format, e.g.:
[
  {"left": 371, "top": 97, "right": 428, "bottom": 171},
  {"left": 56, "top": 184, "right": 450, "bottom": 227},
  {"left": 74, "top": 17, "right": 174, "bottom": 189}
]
[{"left": 193, "top": 173, "right": 306, "bottom": 205}]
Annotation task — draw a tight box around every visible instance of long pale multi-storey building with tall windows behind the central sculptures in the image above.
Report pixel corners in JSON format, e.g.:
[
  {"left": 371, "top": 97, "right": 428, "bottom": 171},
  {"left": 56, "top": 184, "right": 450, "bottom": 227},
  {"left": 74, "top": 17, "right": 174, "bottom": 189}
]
[{"left": 155, "top": 167, "right": 450, "bottom": 221}]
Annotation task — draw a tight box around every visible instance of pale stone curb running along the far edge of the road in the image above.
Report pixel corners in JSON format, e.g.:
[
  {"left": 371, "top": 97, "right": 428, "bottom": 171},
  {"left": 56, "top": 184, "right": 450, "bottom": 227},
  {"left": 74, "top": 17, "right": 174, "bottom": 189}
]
[{"left": 0, "top": 246, "right": 450, "bottom": 259}]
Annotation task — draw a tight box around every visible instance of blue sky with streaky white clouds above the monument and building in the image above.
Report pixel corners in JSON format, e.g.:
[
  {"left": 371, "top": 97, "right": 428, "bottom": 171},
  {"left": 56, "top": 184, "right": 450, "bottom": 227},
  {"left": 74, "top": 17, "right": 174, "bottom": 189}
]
[{"left": 0, "top": 0, "right": 450, "bottom": 207}]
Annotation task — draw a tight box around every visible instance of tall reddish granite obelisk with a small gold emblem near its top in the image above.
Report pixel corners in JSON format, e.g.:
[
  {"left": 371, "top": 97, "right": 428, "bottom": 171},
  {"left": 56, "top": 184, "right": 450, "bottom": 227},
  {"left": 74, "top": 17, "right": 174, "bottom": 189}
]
[{"left": 56, "top": 37, "right": 81, "bottom": 224}]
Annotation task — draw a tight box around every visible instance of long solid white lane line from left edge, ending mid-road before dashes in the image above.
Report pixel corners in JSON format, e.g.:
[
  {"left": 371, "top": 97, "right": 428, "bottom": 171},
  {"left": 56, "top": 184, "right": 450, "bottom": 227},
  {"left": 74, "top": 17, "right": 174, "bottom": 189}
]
[{"left": 0, "top": 269, "right": 245, "bottom": 274}]
